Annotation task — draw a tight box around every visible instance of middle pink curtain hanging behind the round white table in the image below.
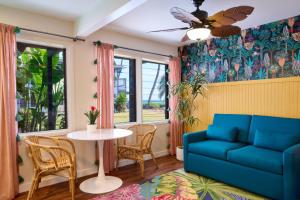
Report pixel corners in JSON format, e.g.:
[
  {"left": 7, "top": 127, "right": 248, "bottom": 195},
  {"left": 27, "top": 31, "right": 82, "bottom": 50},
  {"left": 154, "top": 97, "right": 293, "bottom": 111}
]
[{"left": 96, "top": 44, "right": 116, "bottom": 173}]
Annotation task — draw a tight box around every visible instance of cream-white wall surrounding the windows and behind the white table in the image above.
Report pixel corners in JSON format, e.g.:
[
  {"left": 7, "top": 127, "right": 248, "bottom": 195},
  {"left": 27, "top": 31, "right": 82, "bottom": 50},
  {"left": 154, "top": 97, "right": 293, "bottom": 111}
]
[{"left": 0, "top": 7, "right": 177, "bottom": 192}]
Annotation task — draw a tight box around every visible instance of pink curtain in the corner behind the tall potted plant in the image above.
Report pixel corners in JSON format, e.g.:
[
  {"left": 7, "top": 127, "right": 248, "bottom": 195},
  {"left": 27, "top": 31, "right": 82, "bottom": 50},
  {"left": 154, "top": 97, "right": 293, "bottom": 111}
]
[{"left": 169, "top": 57, "right": 183, "bottom": 155}]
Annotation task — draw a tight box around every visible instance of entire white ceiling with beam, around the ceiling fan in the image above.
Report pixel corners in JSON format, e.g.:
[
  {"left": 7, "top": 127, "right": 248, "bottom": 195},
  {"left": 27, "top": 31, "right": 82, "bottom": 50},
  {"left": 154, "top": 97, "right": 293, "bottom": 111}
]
[{"left": 0, "top": 0, "right": 300, "bottom": 45}]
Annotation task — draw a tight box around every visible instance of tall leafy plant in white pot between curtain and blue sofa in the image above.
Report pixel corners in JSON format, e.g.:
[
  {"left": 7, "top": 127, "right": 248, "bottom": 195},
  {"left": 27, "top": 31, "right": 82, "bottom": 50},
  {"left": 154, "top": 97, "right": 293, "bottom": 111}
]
[{"left": 171, "top": 71, "right": 207, "bottom": 160}]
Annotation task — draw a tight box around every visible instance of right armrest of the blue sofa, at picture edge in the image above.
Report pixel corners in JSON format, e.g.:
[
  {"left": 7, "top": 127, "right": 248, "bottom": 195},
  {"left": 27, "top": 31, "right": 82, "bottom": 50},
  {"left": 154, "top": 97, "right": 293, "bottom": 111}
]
[{"left": 283, "top": 144, "right": 300, "bottom": 200}]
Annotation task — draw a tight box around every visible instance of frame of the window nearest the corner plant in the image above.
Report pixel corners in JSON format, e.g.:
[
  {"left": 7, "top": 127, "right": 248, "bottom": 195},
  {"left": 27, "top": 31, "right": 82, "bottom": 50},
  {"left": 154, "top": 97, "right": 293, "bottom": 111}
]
[{"left": 140, "top": 59, "right": 169, "bottom": 123}]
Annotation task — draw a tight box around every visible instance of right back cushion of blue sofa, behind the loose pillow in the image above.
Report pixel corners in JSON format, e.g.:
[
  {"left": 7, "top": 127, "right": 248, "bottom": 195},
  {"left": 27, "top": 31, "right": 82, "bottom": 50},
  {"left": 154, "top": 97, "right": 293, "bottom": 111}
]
[{"left": 249, "top": 115, "right": 300, "bottom": 144}]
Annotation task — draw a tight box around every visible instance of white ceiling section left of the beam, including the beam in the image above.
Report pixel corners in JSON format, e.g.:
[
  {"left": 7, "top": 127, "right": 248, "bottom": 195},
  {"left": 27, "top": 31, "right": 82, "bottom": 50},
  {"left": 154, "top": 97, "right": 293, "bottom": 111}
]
[{"left": 0, "top": 0, "right": 147, "bottom": 37}]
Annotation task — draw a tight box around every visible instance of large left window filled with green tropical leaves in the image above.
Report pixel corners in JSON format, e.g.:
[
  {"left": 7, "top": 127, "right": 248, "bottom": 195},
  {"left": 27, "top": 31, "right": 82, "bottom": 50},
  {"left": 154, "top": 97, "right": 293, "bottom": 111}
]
[{"left": 17, "top": 43, "right": 68, "bottom": 133}]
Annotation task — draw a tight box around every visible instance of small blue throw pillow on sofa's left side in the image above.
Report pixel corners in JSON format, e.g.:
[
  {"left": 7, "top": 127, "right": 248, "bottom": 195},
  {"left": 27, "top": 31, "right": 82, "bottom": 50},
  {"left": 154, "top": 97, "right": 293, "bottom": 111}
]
[{"left": 206, "top": 125, "right": 238, "bottom": 142}]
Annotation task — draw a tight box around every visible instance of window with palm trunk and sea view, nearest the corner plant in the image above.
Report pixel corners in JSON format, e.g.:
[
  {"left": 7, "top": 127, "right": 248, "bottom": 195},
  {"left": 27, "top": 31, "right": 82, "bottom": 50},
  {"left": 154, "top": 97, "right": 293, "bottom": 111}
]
[{"left": 142, "top": 61, "right": 169, "bottom": 122}]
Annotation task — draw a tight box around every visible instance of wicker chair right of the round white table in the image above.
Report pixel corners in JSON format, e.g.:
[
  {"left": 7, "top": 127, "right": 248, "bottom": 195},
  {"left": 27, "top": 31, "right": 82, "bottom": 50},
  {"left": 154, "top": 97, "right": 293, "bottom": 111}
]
[{"left": 117, "top": 124, "right": 158, "bottom": 177}]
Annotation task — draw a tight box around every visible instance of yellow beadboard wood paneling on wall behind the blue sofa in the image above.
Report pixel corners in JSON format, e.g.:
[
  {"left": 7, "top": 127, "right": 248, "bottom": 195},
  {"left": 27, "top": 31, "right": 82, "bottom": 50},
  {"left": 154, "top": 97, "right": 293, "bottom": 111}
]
[{"left": 190, "top": 77, "right": 300, "bottom": 131}]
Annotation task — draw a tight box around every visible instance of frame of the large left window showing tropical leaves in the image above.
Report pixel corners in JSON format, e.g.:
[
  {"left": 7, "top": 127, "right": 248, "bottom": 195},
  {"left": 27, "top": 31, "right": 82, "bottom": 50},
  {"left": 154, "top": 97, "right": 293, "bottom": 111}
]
[{"left": 16, "top": 40, "right": 70, "bottom": 135}]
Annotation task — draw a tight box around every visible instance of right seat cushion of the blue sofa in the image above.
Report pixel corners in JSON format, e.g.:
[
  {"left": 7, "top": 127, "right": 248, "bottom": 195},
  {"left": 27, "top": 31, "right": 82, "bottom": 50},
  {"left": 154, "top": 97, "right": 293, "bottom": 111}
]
[{"left": 227, "top": 145, "right": 283, "bottom": 174}]
